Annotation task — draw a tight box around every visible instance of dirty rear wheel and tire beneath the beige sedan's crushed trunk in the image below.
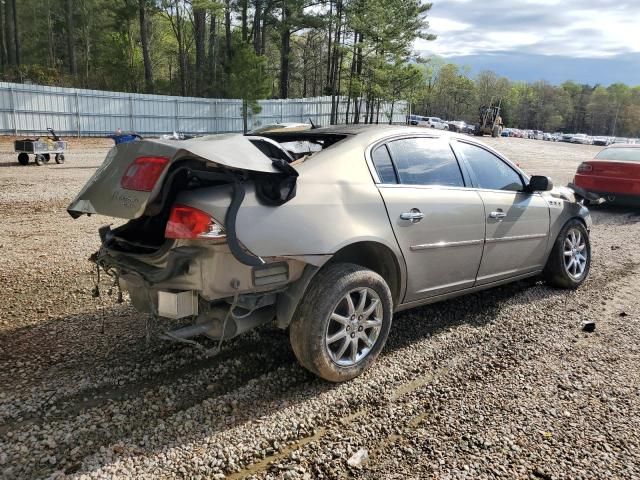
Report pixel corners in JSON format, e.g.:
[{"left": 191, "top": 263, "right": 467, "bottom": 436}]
[{"left": 289, "top": 263, "right": 393, "bottom": 382}]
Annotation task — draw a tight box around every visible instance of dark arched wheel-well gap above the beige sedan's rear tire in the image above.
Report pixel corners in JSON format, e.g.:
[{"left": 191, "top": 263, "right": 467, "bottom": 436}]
[{"left": 327, "top": 242, "right": 401, "bottom": 305}]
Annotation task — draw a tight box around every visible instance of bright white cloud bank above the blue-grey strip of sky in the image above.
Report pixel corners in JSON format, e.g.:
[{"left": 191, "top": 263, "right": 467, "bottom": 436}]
[{"left": 415, "top": 0, "right": 640, "bottom": 58}]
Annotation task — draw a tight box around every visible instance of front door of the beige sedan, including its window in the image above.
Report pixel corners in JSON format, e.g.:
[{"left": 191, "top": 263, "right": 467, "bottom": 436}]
[{"left": 453, "top": 141, "right": 549, "bottom": 285}]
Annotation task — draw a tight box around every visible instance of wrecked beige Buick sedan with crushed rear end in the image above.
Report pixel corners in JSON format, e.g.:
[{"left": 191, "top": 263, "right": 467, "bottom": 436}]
[{"left": 68, "top": 126, "right": 591, "bottom": 382}]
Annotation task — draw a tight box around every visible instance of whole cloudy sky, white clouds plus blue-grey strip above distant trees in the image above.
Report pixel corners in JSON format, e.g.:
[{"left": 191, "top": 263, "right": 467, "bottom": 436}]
[{"left": 416, "top": 0, "right": 640, "bottom": 84}]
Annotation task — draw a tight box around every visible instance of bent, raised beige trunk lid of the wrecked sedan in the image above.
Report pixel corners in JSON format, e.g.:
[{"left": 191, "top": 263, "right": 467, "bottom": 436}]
[{"left": 67, "top": 134, "right": 282, "bottom": 220}]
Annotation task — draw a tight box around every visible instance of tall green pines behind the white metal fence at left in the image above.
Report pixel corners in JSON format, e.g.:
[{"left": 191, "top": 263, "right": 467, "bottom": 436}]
[{"left": 0, "top": 0, "right": 432, "bottom": 122}]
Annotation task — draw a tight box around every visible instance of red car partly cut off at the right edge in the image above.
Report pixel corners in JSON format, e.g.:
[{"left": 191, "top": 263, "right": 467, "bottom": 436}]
[{"left": 573, "top": 144, "right": 640, "bottom": 203}]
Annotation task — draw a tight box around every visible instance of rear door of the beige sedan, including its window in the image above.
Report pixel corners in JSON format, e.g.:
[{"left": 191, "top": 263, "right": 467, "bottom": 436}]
[{"left": 371, "top": 137, "right": 485, "bottom": 303}]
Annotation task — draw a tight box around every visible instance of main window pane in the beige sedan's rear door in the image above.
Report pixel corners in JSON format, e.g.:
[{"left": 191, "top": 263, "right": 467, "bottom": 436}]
[{"left": 388, "top": 138, "right": 464, "bottom": 187}]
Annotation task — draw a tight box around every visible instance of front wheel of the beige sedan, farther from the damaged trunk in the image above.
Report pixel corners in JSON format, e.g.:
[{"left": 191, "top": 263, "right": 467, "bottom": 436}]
[{"left": 543, "top": 219, "right": 591, "bottom": 289}]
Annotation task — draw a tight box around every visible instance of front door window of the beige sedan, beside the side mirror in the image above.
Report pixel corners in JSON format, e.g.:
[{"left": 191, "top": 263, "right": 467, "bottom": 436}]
[{"left": 456, "top": 142, "right": 524, "bottom": 192}]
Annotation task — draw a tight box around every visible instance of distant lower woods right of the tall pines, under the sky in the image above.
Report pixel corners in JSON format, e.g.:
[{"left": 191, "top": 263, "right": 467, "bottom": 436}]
[{"left": 416, "top": 62, "right": 640, "bottom": 137}]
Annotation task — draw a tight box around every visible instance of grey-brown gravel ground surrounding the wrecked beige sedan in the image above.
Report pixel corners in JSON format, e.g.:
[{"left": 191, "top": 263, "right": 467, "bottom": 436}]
[{"left": 0, "top": 138, "right": 640, "bottom": 479}]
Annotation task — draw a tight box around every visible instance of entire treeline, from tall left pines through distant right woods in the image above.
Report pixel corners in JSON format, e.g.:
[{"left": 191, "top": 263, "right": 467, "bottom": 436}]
[{"left": 0, "top": 0, "right": 640, "bottom": 136}]
